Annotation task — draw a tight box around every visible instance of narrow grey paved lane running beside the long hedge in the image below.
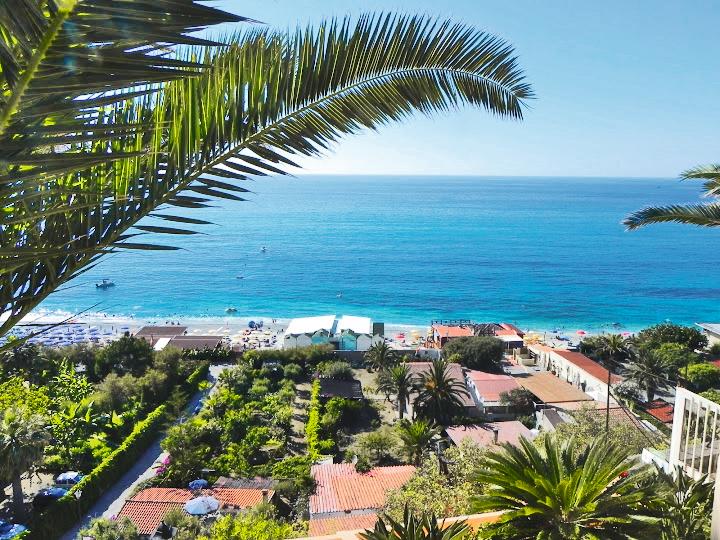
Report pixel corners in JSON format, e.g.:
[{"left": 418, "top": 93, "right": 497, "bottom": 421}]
[{"left": 60, "top": 365, "right": 230, "bottom": 540}]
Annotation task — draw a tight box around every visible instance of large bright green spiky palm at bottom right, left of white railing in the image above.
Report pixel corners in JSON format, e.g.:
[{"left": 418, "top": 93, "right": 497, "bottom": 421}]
[{"left": 474, "top": 437, "right": 653, "bottom": 540}]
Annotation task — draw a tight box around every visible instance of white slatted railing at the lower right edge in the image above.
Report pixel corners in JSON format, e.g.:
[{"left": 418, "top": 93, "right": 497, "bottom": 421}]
[{"left": 669, "top": 388, "right": 720, "bottom": 480}]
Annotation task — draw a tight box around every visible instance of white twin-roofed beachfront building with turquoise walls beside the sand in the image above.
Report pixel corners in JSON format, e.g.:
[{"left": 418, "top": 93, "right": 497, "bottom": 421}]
[{"left": 283, "top": 315, "right": 385, "bottom": 351}]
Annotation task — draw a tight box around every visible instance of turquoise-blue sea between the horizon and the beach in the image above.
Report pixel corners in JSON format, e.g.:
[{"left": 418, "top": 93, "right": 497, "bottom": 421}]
[{"left": 41, "top": 176, "right": 720, "bottom": 329}]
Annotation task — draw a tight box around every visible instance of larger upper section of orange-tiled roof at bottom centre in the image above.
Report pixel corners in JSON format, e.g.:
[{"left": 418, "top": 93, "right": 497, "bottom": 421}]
[{"left": 310, "top": 463, "right": 415, "bottom": 516}]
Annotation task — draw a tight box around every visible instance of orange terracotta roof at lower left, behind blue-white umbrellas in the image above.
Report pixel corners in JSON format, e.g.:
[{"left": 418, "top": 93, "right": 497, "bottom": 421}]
[{"left": 118, "top": 488, "right": 275, "bottom": 534}]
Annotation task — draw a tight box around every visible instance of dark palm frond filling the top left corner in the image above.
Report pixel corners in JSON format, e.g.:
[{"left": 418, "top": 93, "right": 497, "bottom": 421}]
[{"left": 0, "top": 0, "right": 244, "bottom": 175}]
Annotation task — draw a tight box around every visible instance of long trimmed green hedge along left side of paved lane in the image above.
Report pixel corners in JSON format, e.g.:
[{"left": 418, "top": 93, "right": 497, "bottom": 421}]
[{"left": 28, "top": 363, "right": 210, "bottom": 540}]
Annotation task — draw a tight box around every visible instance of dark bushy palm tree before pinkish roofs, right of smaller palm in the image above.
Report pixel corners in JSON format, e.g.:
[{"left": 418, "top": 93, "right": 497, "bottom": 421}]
[{"left": 415, "top": 358, "right": 469, "bottom": 425}]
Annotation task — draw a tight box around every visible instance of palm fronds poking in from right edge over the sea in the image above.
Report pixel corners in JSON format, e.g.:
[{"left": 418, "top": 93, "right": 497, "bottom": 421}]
[{"left": 623, "top": 164, "right": 720, "bottom": 230}]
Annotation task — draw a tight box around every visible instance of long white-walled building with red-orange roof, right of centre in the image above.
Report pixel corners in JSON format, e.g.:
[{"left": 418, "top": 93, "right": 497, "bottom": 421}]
[{"left": 528, "top": 344, "right": 623, "bottom": 404}]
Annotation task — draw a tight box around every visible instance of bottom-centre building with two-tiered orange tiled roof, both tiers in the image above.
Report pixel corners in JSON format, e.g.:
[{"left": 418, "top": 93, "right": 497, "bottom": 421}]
[{"left": 308, "top": 463, "right": 415, "bottom": 536}]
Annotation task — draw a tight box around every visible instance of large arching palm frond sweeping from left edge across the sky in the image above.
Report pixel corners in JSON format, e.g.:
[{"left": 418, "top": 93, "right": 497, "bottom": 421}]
[{"left": 0, "top": 14, "right": 532, "bottom": 340}]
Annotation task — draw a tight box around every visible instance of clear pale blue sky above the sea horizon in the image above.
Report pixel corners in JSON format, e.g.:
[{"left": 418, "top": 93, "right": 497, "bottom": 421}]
[{"left": 213, "top": 0, "right": 720, "bottom": 178}]
